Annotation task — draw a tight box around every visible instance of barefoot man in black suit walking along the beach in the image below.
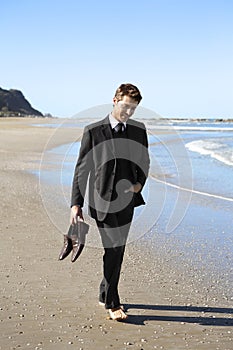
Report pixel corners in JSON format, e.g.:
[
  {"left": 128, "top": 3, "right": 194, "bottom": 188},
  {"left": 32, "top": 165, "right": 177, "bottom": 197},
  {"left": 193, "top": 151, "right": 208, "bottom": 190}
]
[{"left": 71, "top": 84, "right": 149, "bottom": 320}]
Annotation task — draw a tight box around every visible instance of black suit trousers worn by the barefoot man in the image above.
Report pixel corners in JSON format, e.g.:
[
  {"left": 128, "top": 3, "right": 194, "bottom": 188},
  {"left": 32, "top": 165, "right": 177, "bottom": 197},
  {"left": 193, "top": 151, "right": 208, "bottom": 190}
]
[{"left": 96, "top": 206, "right": 133, "bottom": 309}]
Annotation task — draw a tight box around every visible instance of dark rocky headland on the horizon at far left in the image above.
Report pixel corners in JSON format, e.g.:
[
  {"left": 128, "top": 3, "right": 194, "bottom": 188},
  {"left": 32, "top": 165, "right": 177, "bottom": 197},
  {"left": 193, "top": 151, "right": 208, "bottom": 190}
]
[{"left": 0, "top": 88, "right": 45, "bottom": 117}]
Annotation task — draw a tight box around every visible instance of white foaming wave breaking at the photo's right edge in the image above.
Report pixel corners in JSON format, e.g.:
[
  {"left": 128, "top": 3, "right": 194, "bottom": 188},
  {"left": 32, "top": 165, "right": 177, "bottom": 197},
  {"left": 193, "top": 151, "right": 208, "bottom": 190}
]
[{"left": 185, "top": 139, "right": 233, "bottom": 166}]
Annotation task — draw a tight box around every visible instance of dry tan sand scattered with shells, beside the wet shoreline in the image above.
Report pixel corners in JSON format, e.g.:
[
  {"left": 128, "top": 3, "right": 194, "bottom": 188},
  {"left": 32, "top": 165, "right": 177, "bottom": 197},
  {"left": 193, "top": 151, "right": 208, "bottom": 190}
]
[{"left": 0, "top": 118, "right": 233, "bottom": 350}]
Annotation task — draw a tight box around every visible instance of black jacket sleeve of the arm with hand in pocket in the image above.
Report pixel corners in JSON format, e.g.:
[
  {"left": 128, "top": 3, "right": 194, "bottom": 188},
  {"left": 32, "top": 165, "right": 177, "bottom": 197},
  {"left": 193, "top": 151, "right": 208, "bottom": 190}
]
[{"left": 137, "top": 129, "right": 150, "bottom": 187}]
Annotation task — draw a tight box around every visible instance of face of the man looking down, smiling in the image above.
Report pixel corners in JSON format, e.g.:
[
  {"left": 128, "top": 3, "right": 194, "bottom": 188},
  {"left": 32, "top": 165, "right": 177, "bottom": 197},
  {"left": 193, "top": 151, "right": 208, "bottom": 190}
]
[{"left": 112, "top": 96, "right": 138, "bottom": 123}]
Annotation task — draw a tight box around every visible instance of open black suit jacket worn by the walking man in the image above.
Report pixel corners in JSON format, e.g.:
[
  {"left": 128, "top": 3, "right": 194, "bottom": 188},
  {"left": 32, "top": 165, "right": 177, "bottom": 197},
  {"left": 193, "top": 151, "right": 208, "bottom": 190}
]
[{"left": 71, "top": 116, "right": 149, "bottom": 221}]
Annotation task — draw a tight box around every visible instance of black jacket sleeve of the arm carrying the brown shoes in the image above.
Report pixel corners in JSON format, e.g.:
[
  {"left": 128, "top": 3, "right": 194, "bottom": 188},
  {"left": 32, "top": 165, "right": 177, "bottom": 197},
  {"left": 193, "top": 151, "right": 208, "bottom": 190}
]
[{"left": 71, "top": 127, "right": 93, "bottom": 207}]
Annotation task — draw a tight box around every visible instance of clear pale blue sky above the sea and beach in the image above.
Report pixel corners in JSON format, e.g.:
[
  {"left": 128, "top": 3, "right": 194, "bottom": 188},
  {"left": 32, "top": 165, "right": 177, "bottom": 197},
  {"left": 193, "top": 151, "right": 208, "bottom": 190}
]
[{"left": 0, "top": 0, "right": 233, "bottom": 118}]
